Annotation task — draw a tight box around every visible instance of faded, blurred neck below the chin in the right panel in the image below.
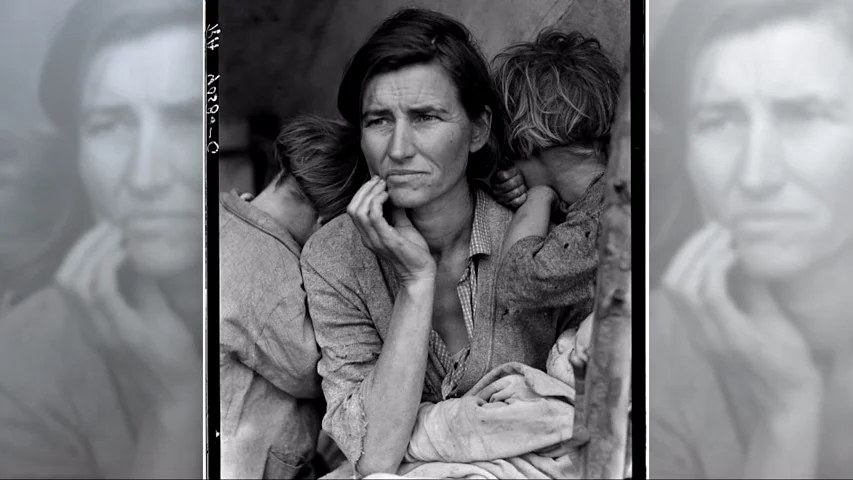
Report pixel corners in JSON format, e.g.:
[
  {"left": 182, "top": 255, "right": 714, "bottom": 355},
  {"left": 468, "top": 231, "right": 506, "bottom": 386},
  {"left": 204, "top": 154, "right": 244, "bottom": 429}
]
[{"left": 771, "top": 244, "right": 853, "bottom": 361}]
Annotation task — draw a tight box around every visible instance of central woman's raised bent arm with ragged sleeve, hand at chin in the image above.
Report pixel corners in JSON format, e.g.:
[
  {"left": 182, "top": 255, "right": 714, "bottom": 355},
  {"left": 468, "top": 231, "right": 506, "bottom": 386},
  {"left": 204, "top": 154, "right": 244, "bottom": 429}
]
[{"left": 303, "top": 178, "right": 436, "bottom": 475}]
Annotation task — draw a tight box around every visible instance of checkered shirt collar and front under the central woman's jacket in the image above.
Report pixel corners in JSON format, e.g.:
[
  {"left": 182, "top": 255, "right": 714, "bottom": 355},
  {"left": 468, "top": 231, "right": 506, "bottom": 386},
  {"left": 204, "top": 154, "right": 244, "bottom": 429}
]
[{"left": 429, "top": 190, "right": 491, "bottom": 399}]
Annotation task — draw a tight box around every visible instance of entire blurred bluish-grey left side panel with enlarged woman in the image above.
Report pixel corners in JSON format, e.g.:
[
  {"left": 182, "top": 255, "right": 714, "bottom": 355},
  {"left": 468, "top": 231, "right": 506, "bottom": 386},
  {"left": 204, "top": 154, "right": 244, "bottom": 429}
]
[{"left": 0, "top": 0, "right": 204, "bottom": 478}]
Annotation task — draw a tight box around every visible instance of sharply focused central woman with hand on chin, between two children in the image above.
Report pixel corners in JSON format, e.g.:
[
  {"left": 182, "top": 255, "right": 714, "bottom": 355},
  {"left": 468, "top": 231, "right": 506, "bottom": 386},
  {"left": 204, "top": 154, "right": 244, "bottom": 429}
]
[{"left": 302, "top": 9, "right": 588, "bottom": 475}]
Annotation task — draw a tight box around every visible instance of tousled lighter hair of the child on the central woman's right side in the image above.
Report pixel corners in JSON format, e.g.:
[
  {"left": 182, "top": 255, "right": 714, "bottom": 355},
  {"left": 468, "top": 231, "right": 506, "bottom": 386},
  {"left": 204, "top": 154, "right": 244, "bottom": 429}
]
[{"left": 493, "top": 29, "right": 619, "bottom": 159}]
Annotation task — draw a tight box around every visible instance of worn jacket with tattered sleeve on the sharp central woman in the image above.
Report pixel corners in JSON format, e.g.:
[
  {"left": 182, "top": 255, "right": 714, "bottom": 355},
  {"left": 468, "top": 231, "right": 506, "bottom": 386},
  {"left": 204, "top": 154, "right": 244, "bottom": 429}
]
[{"left": 302, "top": 188, "right": 588, "bottom": 465}]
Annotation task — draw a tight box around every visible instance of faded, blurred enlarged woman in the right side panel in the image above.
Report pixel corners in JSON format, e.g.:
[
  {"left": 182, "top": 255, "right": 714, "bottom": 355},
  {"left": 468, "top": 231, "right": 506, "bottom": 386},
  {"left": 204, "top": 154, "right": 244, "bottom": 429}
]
[{"left": 649, "top": 0, "right": 853, "bottom": 478}]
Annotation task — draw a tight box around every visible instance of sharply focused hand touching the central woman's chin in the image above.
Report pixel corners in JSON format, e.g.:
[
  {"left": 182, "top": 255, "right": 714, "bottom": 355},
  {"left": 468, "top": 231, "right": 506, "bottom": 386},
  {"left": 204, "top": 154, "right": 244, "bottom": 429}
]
[{"left": 347, "top": 176, "right": 436, "bottom": 285}]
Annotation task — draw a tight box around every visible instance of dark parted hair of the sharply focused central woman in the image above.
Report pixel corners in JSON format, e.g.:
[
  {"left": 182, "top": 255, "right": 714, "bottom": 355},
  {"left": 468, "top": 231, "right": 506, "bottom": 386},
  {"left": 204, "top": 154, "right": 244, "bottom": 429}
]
[{"left": 338, "top": 8, "right": 505, "bottom": 180}]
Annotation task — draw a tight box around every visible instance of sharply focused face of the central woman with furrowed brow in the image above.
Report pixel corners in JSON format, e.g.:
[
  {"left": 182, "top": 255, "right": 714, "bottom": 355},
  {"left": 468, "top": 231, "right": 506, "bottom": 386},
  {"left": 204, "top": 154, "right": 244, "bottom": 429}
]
[{"left": 361, "top": 64, "right": 490, "bottom": 208}]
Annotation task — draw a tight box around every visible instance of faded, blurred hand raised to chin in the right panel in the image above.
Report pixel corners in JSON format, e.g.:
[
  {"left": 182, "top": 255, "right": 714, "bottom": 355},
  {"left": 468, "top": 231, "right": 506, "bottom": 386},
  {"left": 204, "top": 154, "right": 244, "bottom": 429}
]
[{"left": 663, "top": 224, "right": 821, "bottom": 412}]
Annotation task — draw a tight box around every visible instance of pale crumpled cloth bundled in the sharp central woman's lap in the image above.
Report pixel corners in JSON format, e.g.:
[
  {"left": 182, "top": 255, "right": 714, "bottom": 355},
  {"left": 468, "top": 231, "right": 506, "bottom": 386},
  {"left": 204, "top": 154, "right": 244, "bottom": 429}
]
[{"left": 398, "top": 362, "right": 579, "bottom": 478}]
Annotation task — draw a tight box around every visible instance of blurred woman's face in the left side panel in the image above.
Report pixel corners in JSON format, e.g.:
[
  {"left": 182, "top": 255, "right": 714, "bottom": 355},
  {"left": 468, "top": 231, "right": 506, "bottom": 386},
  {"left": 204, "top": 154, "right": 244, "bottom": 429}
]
[{"left": 79, "top": 26, "right": 204, "bottom": 276}]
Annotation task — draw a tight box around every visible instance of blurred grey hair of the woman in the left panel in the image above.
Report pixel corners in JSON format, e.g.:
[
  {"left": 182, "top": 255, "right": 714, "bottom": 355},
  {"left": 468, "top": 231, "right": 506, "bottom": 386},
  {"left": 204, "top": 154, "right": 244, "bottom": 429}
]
[{"left": 39, "top": 0, "right": 203, "bottom": 133}]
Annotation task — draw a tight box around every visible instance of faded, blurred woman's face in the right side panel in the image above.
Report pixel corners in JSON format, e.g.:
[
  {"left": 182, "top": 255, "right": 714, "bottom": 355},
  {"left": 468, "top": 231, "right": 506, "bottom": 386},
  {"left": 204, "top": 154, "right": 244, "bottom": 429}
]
[{"left": 687, "top": 20, "right": 853, "bottom": 279}]
